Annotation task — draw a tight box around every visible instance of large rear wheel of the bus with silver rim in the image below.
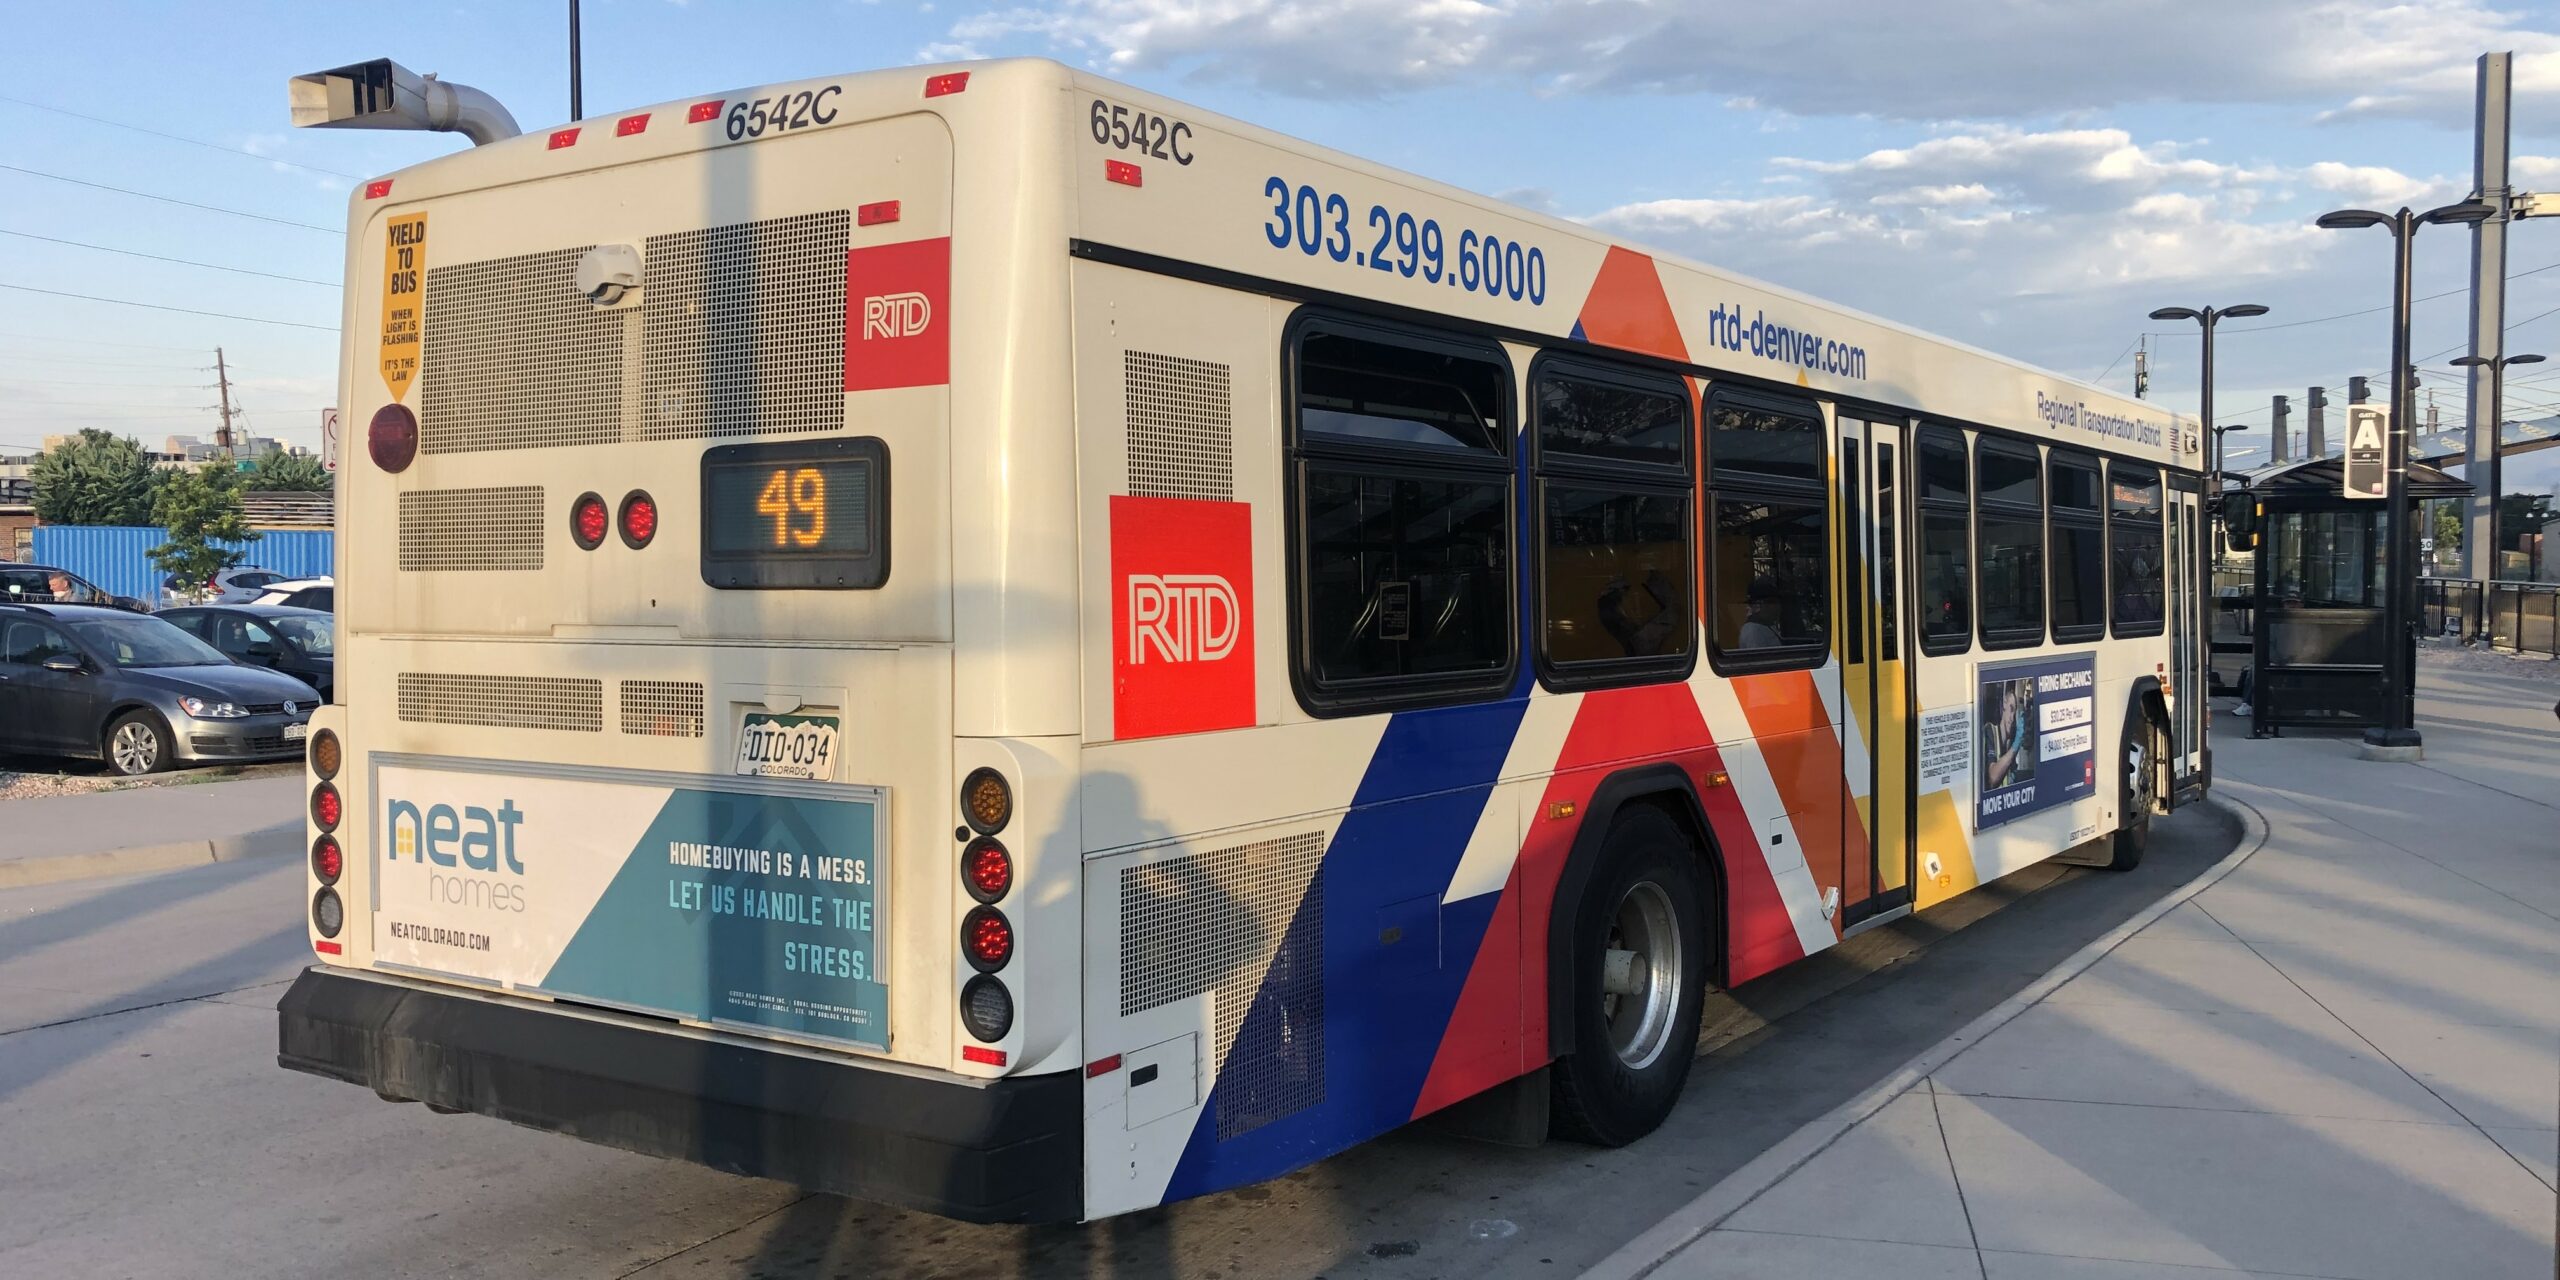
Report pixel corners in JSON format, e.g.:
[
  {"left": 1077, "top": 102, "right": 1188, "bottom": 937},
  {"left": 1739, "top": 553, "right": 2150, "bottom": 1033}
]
[{"left": 1551, "top": 804, "right": 1708, "bottom": 1147}]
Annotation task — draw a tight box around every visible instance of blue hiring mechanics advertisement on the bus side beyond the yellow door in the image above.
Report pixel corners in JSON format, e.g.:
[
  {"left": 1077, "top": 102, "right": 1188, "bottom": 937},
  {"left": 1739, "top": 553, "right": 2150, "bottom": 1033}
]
[{"left": 1974, "top": 653, "right": 2097, "bottom": 832}]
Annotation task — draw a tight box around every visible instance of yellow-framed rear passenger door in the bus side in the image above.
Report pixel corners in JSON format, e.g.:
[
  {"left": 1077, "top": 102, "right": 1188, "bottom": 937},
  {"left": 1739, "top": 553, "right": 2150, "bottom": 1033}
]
[{"left": 1838, "top": 415, "right": 1912, "bottom": 932}]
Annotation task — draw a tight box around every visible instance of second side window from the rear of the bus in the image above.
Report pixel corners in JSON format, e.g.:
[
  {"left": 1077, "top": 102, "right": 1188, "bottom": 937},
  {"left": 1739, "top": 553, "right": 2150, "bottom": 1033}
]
[{"left": 1528, "top": 358, "right": 1697, "bottom": 689}]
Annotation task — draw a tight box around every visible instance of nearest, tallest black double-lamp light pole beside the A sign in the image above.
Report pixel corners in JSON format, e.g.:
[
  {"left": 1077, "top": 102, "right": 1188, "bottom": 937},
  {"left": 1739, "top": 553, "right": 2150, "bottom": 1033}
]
[{"left": 2314, "top": 200, "right": 2499, "bottom": 760}]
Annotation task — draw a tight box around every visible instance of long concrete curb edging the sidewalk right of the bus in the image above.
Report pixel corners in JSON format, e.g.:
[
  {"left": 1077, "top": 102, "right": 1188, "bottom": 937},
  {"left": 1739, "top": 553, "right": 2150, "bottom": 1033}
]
[{"left": 1582, "top": 796, "right": 2268, "bottom": 1280}]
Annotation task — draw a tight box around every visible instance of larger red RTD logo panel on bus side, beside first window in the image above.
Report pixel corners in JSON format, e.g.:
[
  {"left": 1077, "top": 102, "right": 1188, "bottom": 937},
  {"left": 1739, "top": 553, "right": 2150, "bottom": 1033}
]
[{"left": 1111, "top": 497, "right": 1254, "bottom": 740}]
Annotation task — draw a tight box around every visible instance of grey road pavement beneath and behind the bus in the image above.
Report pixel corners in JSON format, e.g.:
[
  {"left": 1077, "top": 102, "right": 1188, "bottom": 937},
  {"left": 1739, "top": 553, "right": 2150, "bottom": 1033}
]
[{"left": 0, "top": 773, "right": 2237, "bottom": 1280}]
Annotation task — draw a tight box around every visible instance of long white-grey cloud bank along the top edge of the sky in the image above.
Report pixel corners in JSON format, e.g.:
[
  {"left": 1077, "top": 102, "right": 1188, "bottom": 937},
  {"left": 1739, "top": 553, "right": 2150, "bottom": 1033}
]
[{"left": 952, "top": 0, "right": 2560, "bottom": 123}]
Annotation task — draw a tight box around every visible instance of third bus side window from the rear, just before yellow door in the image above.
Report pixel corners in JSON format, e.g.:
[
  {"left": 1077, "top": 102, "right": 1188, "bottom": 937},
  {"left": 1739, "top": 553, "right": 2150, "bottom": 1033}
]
[{"left": 1708, "top": 394, "right": 1830, "bottom": 671}]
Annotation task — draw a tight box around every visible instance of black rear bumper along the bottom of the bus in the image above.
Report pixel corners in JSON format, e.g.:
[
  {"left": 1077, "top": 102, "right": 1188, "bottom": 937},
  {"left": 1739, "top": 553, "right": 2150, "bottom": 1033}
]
[{"left": 276, "top": 965, "right": 1083, "bottom": 1221}]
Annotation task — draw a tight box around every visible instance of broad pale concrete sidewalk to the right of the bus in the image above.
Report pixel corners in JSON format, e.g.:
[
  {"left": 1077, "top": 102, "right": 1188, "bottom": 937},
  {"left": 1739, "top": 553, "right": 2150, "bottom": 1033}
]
[{"left": 1590, "top": 666, "right": 2560, "bottom": 1280}]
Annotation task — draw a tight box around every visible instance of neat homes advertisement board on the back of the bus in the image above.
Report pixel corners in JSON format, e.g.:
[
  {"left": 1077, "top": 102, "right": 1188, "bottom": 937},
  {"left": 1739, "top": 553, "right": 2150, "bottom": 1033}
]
[{"left": 371, "top": 763, "right": 888, "bottom": 1050}]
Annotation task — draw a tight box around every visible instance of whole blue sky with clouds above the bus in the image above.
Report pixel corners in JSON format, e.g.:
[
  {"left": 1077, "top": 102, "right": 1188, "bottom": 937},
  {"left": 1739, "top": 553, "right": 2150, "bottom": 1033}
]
[{"left": 0, "top": 0, "right": 2560, "bottom": 451}]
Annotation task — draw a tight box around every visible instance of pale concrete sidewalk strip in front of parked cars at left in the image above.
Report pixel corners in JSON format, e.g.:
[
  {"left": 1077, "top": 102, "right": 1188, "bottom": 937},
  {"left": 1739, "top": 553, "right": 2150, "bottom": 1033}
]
[{"left": 0, "top": 776, "right": 302, "bottom": 888}]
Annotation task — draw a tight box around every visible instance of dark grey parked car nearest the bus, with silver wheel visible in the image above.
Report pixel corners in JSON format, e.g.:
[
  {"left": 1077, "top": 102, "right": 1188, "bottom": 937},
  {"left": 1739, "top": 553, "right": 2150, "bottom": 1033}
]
[{"left": 0, "top": 604, "right": 320, "bottom": 773}]
